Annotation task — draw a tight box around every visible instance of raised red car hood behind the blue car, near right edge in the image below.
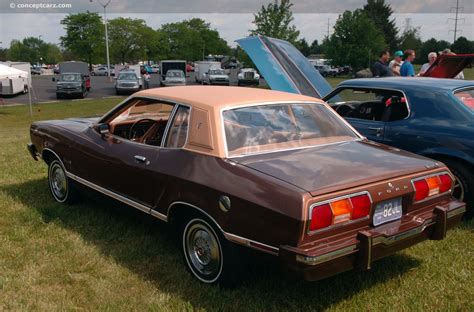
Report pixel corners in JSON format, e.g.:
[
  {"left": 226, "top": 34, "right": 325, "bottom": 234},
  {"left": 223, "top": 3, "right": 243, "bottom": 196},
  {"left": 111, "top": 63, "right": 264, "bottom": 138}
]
[{"left": 423, "top": 54, "right": 474, "bottom": 78}]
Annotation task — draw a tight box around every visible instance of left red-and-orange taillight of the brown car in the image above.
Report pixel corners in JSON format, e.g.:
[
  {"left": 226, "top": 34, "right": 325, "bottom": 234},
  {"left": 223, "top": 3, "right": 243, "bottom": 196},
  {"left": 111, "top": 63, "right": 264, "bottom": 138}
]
[{"left": 309, "top": 193, "right": 372, "bottom": 231}]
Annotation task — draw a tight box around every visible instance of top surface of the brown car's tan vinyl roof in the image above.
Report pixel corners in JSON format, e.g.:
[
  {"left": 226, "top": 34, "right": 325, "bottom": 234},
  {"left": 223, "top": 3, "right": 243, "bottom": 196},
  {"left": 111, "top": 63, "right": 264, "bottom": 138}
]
[{"left": 134, "top": 86, "right": 320, "bottom": 109}]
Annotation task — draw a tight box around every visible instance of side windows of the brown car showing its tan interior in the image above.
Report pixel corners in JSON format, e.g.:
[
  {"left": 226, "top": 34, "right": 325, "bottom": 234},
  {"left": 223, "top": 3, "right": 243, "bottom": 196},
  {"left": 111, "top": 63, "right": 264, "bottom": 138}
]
[{"left": 109, "top": 99, "right": 189, "bottom": 148}]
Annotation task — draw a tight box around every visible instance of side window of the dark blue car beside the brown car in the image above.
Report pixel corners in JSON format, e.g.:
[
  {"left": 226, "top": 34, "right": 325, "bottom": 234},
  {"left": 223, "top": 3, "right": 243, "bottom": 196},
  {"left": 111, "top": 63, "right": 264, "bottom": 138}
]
[{"left": 328, "top": 89, "right": 409, "bottom": 122}]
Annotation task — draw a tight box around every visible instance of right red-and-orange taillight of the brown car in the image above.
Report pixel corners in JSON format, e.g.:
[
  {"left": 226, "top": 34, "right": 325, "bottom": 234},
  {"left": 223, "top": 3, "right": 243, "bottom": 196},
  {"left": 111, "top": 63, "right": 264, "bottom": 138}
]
[{"left": 412, "top": 173, "right": 453, "bottom": 202}]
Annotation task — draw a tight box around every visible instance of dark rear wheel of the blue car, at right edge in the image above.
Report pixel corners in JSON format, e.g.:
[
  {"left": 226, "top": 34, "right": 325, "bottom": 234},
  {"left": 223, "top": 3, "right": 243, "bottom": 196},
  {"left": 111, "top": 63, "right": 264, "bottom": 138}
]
[{"left": 442, "top": 159, "right": 474, "bottom": 219}]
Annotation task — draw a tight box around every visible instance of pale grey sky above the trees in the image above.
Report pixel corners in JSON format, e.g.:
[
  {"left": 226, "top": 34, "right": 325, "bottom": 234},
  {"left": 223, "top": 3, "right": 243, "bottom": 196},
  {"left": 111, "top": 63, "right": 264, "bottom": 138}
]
[{"left": 0, "top": 0, "right": 474, "bottom": 48}]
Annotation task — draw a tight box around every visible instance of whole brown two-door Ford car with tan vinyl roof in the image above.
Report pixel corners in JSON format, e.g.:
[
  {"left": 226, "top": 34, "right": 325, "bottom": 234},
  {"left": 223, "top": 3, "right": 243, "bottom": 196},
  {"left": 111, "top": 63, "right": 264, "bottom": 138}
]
[{"left": 28, "top": 86, "right": 465, "bottom": 283}]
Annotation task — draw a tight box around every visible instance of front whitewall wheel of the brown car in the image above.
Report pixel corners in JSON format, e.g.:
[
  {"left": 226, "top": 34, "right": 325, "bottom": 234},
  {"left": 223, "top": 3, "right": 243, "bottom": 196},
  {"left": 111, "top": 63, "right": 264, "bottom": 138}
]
[{"left": 48, "top": 159, "right": 77, "bottom": 204}]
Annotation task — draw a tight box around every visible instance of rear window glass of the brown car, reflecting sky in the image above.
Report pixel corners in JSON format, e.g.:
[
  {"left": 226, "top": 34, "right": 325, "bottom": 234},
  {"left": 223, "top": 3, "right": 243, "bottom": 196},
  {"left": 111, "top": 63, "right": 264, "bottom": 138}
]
[{"left": 223, "top": 103, "right": 358, "bottom": 156}]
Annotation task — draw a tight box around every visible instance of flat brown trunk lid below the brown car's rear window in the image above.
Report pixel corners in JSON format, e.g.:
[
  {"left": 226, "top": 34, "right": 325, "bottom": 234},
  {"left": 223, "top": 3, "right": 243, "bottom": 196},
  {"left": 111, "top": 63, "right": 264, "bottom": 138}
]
[{"left": 233, "top": 140, "right": 439, "bottom": 196}]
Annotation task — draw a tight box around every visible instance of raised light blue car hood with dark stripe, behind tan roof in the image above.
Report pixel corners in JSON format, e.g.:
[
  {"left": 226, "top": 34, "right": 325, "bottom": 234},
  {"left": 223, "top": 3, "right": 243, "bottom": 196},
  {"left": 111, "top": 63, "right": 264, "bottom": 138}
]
[{"left": 236, "top": 35, "right": 332, "bottom": 98}]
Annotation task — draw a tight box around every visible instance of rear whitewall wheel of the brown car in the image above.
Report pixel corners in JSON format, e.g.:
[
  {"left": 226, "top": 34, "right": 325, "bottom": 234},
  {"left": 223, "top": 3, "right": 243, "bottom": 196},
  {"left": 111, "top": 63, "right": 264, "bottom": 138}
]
[{"left": 182, "top": 217, "right": 239, "bottom": 286}]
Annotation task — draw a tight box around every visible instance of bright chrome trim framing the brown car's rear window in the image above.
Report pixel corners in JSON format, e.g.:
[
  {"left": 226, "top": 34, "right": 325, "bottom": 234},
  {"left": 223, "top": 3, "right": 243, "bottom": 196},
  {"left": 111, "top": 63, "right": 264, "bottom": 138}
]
[{"left": 219, "top": 101, "right": 366, "bottom": 158}]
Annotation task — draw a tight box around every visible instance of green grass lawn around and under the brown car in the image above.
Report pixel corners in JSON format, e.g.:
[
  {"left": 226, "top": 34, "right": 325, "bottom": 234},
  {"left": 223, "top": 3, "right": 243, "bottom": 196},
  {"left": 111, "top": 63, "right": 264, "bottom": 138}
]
[{"left": 0, "top": 99, "right": 474, "bottom": 311}]
